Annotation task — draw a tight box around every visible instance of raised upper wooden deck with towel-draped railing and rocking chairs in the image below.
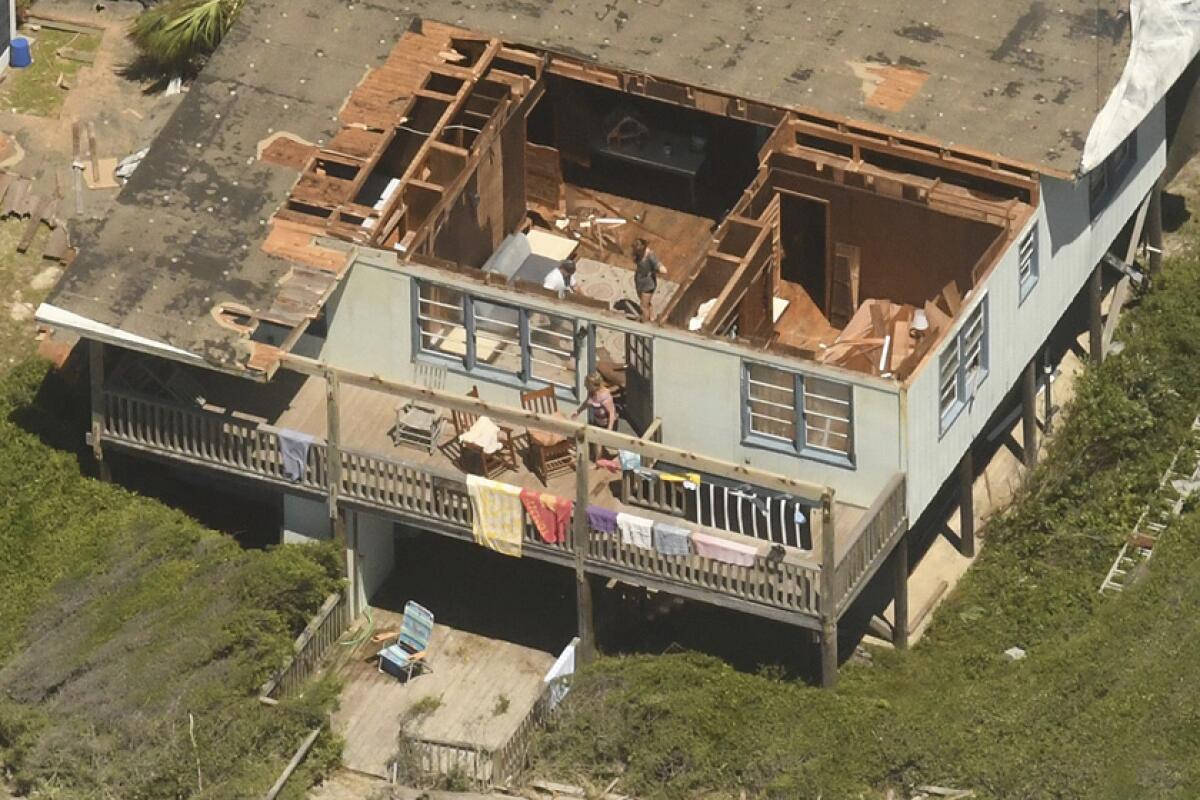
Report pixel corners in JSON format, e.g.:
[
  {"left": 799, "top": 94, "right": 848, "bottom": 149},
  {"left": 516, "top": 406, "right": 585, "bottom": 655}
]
[{"left": 100, "top": 378, "right": 906, "bottom": 630}]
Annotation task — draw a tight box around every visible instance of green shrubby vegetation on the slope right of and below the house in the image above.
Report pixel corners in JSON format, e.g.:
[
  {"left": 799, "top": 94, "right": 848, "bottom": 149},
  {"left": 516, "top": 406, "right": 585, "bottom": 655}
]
[{"left": 533, "top": 255, "right": 1200, "bottom": 799}]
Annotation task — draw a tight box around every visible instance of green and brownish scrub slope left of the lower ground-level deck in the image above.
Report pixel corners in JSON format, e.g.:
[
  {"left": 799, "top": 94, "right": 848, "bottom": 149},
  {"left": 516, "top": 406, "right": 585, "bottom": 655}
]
[{"left": 0, "top": 362, "right": 340, "bottom": 800}]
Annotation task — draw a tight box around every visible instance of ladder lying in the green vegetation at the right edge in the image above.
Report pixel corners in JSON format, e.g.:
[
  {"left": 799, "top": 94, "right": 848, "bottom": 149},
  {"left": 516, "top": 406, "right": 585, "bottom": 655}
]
[{"left": 1100, "top": 416, "right": 1200, "bottom": 595}]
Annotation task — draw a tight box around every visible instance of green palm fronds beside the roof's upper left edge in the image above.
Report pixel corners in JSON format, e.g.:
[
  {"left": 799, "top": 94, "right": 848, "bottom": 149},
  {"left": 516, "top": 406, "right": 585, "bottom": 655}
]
[{"left": 130, "top": 0, "right": 245, "bottom": 76}]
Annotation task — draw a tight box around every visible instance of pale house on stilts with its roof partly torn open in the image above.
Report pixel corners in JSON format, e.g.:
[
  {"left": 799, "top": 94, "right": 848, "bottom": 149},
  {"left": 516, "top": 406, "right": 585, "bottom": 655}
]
[{"left": 37, "top": 0, "right": 1200, "bottom": 685}]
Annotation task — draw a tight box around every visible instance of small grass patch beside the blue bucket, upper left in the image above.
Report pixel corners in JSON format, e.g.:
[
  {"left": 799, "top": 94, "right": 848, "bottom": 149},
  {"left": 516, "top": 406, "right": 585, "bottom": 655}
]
[{"left": 0, "top": 28, "right": 100, "bottom": 116}]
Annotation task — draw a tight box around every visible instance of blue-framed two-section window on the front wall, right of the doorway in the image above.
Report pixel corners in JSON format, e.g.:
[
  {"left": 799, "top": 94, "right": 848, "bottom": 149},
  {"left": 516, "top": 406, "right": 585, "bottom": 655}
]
[{"left": 743, "top": 363, "right": 853, "bottom": 463}]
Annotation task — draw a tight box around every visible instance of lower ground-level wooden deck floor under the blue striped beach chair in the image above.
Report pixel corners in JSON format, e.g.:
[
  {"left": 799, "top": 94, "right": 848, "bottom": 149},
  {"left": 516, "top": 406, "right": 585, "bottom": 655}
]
[{"left": 332, "top": 607, "right": 552, "bottom": 776}]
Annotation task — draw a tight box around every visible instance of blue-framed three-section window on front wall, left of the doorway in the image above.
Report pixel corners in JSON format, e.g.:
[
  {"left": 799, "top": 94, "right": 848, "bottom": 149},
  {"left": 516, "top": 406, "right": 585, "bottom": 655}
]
[{"left": 414, "top": 282, "right": 578, "bottom": 396}]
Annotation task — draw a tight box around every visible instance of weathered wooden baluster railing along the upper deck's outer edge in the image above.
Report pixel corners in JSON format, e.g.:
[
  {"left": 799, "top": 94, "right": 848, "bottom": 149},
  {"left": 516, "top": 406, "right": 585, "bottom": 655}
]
[{"left": 103, "top": 390, "right": 888, "bottom": 615}]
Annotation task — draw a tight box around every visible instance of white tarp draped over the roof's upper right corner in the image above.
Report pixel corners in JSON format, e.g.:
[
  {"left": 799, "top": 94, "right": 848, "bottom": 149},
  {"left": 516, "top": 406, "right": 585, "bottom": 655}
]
[{"left": 1080, "top": 0, "right": 1200, "bottom": 173}]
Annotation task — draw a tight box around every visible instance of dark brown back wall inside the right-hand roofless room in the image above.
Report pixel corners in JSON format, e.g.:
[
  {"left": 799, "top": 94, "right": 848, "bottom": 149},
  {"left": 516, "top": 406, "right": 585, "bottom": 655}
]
[{"left": 770, "top": 170, "right": 1003, "bottom": 306}]
